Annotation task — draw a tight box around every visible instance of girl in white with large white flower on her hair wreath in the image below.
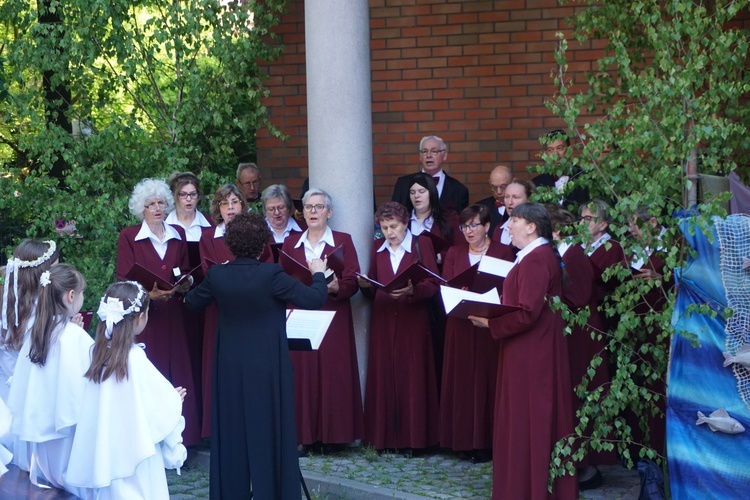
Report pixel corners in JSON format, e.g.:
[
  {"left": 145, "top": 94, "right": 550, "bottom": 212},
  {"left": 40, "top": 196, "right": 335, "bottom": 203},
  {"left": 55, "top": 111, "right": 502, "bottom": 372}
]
[{"left": 67, "top": 281, "right": 187, "bottom": 500}]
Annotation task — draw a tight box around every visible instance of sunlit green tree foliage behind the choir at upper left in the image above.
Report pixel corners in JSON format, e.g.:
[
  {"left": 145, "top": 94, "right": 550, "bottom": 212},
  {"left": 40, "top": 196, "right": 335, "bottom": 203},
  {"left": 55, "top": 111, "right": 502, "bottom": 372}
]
[{"left": 0, "top": 0, "right": 285, "bottom": 304}]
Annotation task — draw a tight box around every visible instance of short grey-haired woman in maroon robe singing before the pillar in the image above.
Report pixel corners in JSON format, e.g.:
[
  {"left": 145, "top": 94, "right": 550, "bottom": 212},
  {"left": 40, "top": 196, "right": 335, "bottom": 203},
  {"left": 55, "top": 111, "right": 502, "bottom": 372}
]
[{"left": 280, "top": 188, "right": 364, "bottom": 455}]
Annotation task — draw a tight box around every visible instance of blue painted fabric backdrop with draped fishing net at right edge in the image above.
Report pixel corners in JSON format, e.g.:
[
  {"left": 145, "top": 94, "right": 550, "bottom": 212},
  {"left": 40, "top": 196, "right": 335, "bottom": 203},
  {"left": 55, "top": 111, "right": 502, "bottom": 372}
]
[{"left": 667, "top": 215, "right": 750, "bottom": 499}]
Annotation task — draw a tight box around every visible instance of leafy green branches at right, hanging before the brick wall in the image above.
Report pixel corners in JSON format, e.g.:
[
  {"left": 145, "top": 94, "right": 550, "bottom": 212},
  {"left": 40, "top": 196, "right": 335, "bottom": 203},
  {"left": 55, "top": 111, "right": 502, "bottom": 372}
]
[{"left": 540, "top": 0, "right": 750, "bottom": 482}]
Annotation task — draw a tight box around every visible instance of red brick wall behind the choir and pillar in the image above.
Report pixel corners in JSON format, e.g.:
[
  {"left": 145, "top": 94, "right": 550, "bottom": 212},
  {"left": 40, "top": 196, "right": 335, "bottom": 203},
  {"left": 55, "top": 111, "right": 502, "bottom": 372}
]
[{"left": 258, "top": 0, "right": 736, "bottom": 203}]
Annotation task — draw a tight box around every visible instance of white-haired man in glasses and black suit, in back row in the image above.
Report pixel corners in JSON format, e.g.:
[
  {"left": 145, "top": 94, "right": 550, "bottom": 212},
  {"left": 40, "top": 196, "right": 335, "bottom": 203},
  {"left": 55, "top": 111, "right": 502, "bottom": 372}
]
[{"left": 391, "top": 135, "right": 469, "bottom": 213}]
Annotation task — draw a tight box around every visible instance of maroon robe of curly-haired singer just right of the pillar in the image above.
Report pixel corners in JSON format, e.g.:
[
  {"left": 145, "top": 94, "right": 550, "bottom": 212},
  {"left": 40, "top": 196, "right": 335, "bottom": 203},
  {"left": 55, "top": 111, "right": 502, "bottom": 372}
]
[{"left": 362, "top": 236, "right": 439, "bottom": 450}]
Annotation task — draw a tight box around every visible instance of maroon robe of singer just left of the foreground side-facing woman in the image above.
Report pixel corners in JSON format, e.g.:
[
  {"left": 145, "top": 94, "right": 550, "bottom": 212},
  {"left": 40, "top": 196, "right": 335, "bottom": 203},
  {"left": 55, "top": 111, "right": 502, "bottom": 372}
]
[{"left": 439, "top": 241, "right": 503, "bottom": 451}]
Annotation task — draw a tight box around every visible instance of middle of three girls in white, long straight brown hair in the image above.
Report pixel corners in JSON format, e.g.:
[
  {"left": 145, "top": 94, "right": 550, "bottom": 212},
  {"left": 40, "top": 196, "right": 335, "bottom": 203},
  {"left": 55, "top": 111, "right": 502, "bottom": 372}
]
[{"left": 8, "top": 264, "right": 93, "bottom": 488}]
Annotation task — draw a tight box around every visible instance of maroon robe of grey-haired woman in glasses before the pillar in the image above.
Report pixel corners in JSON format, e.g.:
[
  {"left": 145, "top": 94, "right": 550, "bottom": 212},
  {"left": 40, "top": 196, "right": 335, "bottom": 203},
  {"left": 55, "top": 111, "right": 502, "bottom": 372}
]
[{"left": 282, "top": 231, "right": 364, "bottom": 445}]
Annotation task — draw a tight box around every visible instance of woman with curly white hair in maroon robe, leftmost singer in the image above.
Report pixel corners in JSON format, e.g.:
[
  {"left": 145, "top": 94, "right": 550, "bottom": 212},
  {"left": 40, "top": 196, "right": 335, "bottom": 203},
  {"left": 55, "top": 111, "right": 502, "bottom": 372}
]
[{"left": 116, "top": 179, "right": 200, "bottom": 446}]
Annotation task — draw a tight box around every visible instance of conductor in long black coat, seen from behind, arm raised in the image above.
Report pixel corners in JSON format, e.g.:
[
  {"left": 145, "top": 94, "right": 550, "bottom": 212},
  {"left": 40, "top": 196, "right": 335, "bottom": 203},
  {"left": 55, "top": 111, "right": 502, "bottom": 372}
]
[{"left": 185, "top": 213, "right": 328, "bottom": 500}]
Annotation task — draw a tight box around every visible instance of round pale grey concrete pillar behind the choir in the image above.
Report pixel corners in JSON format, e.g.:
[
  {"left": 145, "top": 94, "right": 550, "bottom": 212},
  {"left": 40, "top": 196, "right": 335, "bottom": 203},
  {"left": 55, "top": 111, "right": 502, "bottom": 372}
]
[{"left": 305, "top": 0, "right": 373, "bottom": 395}]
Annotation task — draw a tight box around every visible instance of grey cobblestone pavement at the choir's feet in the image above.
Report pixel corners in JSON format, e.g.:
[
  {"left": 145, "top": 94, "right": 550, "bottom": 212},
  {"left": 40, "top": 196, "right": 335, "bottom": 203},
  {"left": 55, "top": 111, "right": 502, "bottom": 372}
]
[{"left": 167, "top": 448, "right": 640, "bottom": 500}]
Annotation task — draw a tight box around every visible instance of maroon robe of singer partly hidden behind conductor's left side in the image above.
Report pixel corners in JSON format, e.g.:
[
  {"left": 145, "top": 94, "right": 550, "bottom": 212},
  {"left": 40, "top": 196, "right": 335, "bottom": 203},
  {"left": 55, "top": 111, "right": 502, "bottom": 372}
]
[{"left": 198, "top": 227, "right": 234, "bottom": 438}]
